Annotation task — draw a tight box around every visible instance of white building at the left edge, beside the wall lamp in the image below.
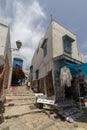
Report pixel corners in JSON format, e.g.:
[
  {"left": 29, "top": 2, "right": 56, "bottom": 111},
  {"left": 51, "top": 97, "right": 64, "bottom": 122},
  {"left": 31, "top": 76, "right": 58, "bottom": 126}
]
[{"left": 0, "top": 20, "right": 12, "bottom": 88}]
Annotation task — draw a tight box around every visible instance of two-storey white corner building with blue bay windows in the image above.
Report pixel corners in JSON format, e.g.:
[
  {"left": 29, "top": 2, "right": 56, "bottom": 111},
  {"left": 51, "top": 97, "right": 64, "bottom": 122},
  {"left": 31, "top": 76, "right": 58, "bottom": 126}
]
[{"left": 30, "top": 21, "right": 84, "bottom": 97}]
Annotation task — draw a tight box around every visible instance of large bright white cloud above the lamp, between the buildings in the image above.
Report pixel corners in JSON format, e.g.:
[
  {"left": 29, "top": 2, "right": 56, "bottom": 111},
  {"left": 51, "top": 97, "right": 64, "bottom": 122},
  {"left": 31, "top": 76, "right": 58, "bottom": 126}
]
[{"left": 0, "top": 0, "right": 46, "bottom": 69}]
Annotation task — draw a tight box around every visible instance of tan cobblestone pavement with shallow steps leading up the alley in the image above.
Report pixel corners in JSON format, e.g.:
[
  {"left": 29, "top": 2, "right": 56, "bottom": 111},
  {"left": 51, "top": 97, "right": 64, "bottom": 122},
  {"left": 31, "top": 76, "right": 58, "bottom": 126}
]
[{"left": 0, "top": 86, "right": 87, "bottom": 130}]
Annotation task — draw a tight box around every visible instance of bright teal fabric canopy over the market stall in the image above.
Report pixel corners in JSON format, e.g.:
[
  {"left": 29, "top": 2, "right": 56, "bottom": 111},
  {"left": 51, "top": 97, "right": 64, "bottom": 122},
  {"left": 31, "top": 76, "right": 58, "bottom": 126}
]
[{"left": 66, "top": 63, "right": 87, "bottom": 75}]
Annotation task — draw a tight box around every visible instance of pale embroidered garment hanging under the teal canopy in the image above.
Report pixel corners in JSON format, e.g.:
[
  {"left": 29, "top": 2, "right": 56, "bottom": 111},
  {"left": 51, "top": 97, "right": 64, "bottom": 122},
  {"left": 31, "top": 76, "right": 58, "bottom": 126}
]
[{"left": 60, "top": 66, "right": 72, "bottom": 87}]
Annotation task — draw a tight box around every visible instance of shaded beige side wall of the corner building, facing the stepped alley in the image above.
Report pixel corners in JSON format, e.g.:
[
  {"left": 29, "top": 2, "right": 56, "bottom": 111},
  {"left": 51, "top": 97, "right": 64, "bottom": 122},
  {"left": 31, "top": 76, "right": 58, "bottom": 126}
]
[{"left": 32, "top": 25, "right": 52, "bottom": 79}]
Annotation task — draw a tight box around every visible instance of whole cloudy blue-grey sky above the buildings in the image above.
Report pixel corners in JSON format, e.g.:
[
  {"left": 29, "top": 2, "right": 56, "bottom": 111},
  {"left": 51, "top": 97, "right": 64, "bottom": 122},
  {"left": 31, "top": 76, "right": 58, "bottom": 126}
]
[{"left": 0, "top": 0, "right": 87, "bottom": 66}]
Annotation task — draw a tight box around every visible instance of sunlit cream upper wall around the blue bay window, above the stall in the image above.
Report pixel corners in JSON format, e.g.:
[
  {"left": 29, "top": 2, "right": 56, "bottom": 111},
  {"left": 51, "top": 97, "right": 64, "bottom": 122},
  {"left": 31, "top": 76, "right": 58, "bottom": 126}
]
[{"left": 52, "top": 21, "right": 84, "bottom": 62}]
